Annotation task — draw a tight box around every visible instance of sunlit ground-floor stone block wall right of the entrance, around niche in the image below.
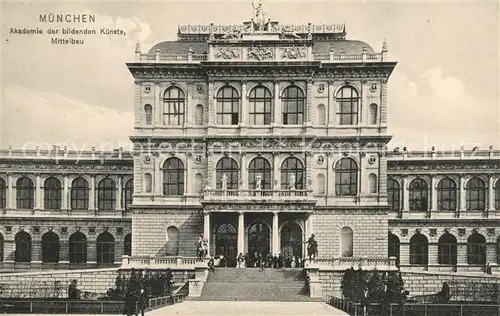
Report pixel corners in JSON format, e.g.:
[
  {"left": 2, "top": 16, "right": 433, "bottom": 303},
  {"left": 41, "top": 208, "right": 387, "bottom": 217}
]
[{"left": 313, "top": 210, "right": 388, "bottom": 258}]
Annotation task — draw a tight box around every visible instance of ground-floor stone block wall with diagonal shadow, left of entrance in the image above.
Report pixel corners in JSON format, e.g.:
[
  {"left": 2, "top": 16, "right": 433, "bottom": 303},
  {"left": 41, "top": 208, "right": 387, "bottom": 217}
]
[{"left": 132, "top": 209, "right": 203, "bottom": 257}]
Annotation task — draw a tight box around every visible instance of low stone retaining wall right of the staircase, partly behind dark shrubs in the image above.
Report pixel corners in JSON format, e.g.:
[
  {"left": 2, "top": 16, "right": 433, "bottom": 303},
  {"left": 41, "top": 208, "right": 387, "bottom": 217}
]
[{"left": 319, "top": 270, "right": 500, "bottom": 297}]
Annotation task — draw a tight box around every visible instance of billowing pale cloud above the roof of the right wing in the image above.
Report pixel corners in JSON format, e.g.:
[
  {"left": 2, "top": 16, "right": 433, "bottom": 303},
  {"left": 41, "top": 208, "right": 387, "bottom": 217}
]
[{"left": 388, "top": 67, "right": 499, "bottom": 149}]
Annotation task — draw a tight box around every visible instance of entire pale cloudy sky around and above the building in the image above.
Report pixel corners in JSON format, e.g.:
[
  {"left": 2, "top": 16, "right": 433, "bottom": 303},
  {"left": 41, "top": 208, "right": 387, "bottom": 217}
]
[{"left": 0, "top": 0, "right": 500, "bottom": 150}]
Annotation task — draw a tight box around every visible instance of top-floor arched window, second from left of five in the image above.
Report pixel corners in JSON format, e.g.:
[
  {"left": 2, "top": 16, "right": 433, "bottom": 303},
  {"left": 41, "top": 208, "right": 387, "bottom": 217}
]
[{"left": 217, "top": 86, "right": 240, "bottom": 125}]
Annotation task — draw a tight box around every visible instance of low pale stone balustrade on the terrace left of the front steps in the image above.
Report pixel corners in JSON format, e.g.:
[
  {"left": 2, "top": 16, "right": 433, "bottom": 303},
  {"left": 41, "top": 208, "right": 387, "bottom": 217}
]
[{"left": 122, "top": 256, "right": 198, "bottom": 269}]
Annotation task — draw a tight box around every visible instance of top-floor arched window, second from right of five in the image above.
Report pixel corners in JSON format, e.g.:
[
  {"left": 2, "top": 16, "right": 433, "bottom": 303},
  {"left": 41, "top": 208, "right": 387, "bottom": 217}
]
[{"left": 281, "top": 86, "right": 305, "bottom": 125}]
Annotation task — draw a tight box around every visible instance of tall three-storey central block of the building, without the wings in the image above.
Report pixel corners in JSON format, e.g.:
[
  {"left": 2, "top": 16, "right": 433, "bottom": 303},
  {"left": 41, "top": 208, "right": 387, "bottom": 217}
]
[{"left": 128, "top": 18, "right": 395, "bottom": 262}]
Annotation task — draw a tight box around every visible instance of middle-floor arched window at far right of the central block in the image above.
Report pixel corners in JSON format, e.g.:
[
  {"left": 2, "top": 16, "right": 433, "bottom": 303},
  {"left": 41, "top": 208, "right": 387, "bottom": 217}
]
[{"left": 335, "top": 158, "right": 358, "bottom": 196}]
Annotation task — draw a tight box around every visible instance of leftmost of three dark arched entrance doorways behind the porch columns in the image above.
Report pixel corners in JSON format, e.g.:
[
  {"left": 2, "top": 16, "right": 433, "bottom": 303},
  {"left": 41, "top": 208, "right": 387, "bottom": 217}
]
[{"left": 215, "top": 223, "right": 237, "bottom": 267}]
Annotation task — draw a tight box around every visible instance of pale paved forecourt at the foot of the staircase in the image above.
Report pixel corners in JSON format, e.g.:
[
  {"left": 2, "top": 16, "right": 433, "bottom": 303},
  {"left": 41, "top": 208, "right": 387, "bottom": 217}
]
[{"left": 147, "top": 301, "right": 349, "bottom": 316}]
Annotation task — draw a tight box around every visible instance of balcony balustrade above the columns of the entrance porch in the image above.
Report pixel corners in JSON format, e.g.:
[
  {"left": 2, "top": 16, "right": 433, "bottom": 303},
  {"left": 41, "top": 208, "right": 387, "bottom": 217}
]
[{"left": 203, "top": 189, "right": 312, "bottom": 200}]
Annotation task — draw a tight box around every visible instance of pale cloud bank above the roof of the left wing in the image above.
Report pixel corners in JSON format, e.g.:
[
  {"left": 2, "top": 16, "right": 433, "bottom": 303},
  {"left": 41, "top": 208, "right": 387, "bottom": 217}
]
[{"left": 2, "top": 86, "right": 134, "bottom": 150}]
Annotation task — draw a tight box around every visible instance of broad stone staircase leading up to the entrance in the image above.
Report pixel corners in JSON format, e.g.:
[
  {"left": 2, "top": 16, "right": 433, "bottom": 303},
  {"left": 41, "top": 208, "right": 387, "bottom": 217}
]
[{"left": 190, "top": 268, "right": 320, "bottom": 302}]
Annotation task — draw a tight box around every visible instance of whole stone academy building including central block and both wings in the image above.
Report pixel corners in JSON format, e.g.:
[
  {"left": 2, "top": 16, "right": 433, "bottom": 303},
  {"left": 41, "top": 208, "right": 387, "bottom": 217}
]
[{"left": 0, "top": 16, "right": 500, "bottom": 270}]
